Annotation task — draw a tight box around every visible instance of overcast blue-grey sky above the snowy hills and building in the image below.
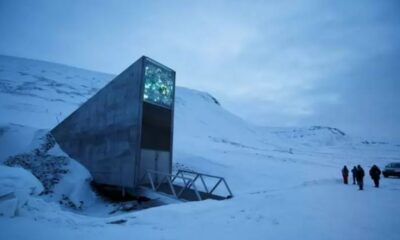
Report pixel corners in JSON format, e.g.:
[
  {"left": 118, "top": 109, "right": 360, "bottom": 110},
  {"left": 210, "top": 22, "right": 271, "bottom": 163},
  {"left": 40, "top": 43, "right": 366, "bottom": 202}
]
[{"left": 0, "top": 0, "right": 400, "bottom": 141}]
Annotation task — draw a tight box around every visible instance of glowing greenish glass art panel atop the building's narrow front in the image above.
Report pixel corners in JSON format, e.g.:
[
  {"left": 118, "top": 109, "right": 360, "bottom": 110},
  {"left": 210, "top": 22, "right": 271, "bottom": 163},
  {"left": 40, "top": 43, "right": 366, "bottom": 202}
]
[{"left": 143, "top": 61, "right": 174, "bottom": 108}]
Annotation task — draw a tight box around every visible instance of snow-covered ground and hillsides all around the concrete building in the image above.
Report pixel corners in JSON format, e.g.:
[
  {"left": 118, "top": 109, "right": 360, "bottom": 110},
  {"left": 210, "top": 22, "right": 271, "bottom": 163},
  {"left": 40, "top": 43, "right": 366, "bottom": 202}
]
[{"left": 0, "top": 56, "right": 400, "bottom": 239}]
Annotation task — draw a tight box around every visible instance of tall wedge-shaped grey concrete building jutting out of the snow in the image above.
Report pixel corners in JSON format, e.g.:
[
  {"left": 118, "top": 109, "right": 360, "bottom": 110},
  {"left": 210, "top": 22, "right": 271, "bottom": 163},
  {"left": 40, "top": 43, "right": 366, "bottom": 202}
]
[{"left": 51, "top": 56, "right": 175, "bottom": 188}]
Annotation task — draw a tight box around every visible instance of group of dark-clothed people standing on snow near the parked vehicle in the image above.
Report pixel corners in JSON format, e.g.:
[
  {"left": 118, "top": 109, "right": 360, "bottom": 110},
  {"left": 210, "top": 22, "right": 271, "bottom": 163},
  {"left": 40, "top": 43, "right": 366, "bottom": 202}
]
[{"left": 342, "top": 164, "right": 381, "bottom": 190}]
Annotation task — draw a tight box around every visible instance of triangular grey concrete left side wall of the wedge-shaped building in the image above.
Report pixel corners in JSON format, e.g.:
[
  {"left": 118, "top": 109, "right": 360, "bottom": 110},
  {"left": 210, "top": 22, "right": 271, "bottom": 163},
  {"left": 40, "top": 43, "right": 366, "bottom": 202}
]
[{"left": 51, "top": 57, "right": 143, "bottom": 187}]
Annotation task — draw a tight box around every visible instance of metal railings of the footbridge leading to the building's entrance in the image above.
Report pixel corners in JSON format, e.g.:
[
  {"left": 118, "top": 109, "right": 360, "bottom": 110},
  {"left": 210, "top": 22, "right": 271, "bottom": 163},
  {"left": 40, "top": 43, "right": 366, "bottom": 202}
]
[{"left": 140, "top": 170, "right": 233, "bottom": 201}]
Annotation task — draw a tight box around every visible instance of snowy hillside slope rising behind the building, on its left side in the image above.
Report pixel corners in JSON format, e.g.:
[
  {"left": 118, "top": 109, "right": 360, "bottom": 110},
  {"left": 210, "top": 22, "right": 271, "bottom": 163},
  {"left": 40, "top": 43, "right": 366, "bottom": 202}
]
[{"left": 0, "top": 56, "right": 113, "bottom": 128}]
